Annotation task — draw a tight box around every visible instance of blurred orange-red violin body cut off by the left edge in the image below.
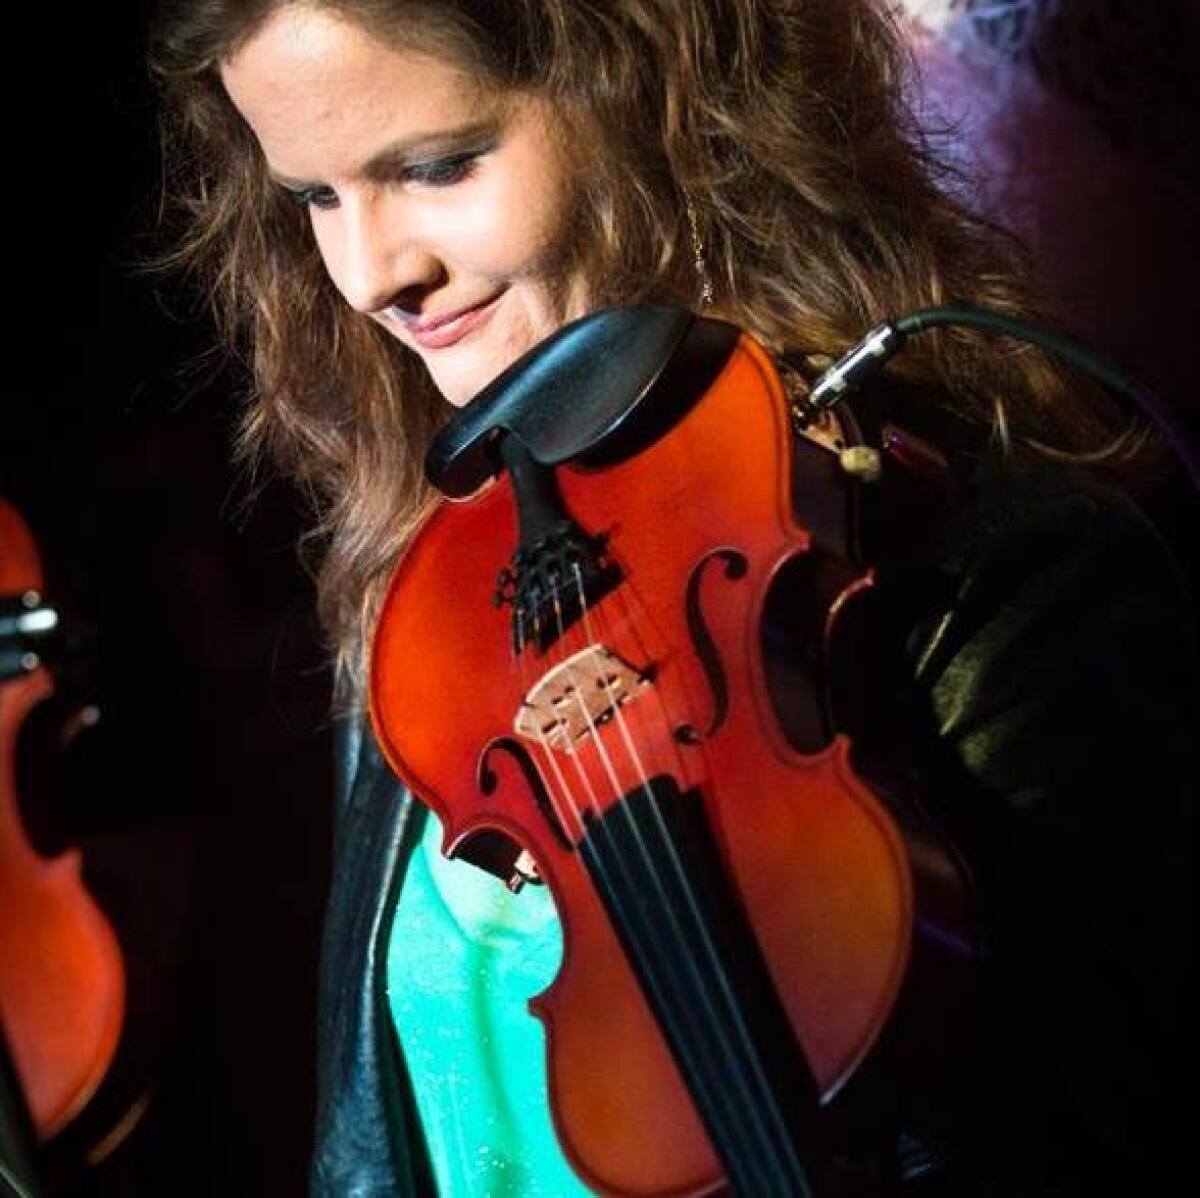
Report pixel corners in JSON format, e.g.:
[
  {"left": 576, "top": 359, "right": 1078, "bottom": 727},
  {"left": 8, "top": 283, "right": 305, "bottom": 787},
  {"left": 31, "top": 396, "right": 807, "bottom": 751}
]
[{"left": 0, "top": 499, "right": 125, "bottom": 1140}]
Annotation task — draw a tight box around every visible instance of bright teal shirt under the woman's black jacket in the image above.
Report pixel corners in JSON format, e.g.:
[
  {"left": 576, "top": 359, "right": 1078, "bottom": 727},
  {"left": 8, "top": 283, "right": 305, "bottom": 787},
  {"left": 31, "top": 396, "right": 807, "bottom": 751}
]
[{"left": 388, "top": 815, "right": 590, "bottom": 1198}]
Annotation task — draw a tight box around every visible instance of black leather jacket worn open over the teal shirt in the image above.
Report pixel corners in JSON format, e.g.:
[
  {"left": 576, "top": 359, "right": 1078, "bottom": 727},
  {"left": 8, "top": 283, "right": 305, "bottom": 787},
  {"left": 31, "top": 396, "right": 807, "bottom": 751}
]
[{"left": 311, "top": 427, "right": 1196, "bottom": 1198}]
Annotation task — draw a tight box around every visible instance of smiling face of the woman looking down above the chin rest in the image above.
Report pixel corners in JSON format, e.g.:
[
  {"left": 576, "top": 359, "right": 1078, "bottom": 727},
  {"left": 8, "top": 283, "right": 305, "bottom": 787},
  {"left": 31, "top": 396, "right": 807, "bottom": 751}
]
[{"left": 221, "top": 5, "right": 587, "bottom": 406}]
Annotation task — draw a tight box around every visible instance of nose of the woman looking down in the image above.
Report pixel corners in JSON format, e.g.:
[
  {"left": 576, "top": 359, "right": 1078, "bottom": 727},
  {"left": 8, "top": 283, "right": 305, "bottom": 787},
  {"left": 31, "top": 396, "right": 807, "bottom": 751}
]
[{"left": 323, "top": 193, "right": 444, "bottom": 315}]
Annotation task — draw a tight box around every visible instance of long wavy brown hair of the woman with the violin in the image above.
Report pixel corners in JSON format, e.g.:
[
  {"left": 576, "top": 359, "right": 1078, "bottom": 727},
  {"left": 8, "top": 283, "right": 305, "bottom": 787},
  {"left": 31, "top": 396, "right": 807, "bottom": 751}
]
[{"left": 151, "top": 0, "right": 1123, "bottom": 677}]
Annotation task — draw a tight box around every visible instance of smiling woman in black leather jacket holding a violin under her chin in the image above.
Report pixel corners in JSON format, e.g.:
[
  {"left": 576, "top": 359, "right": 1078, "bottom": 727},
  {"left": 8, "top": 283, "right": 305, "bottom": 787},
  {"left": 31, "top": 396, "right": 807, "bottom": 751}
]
[{"left": 154, "top": 0, "right": 1187, "bottom": 1194}]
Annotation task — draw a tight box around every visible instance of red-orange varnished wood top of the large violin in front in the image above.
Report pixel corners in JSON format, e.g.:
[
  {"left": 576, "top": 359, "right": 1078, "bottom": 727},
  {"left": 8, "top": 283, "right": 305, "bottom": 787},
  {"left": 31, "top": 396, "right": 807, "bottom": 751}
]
[{"left": 371, "top": 337, "right": 912, "bottom": 1196}]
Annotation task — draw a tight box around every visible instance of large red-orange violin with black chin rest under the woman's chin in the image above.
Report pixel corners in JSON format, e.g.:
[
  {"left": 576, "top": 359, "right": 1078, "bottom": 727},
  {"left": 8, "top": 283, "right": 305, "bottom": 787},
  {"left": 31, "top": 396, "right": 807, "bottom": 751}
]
[{"left": 370, "top": 307, "right": 969, "bottom": 1196}]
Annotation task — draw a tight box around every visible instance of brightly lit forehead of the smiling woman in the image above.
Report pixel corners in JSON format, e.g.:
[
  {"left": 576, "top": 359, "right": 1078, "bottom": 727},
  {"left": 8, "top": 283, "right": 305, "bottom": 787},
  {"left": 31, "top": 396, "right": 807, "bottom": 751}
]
[{"left": 221, "top": 5, "right": 504, "bottom": 180}]
